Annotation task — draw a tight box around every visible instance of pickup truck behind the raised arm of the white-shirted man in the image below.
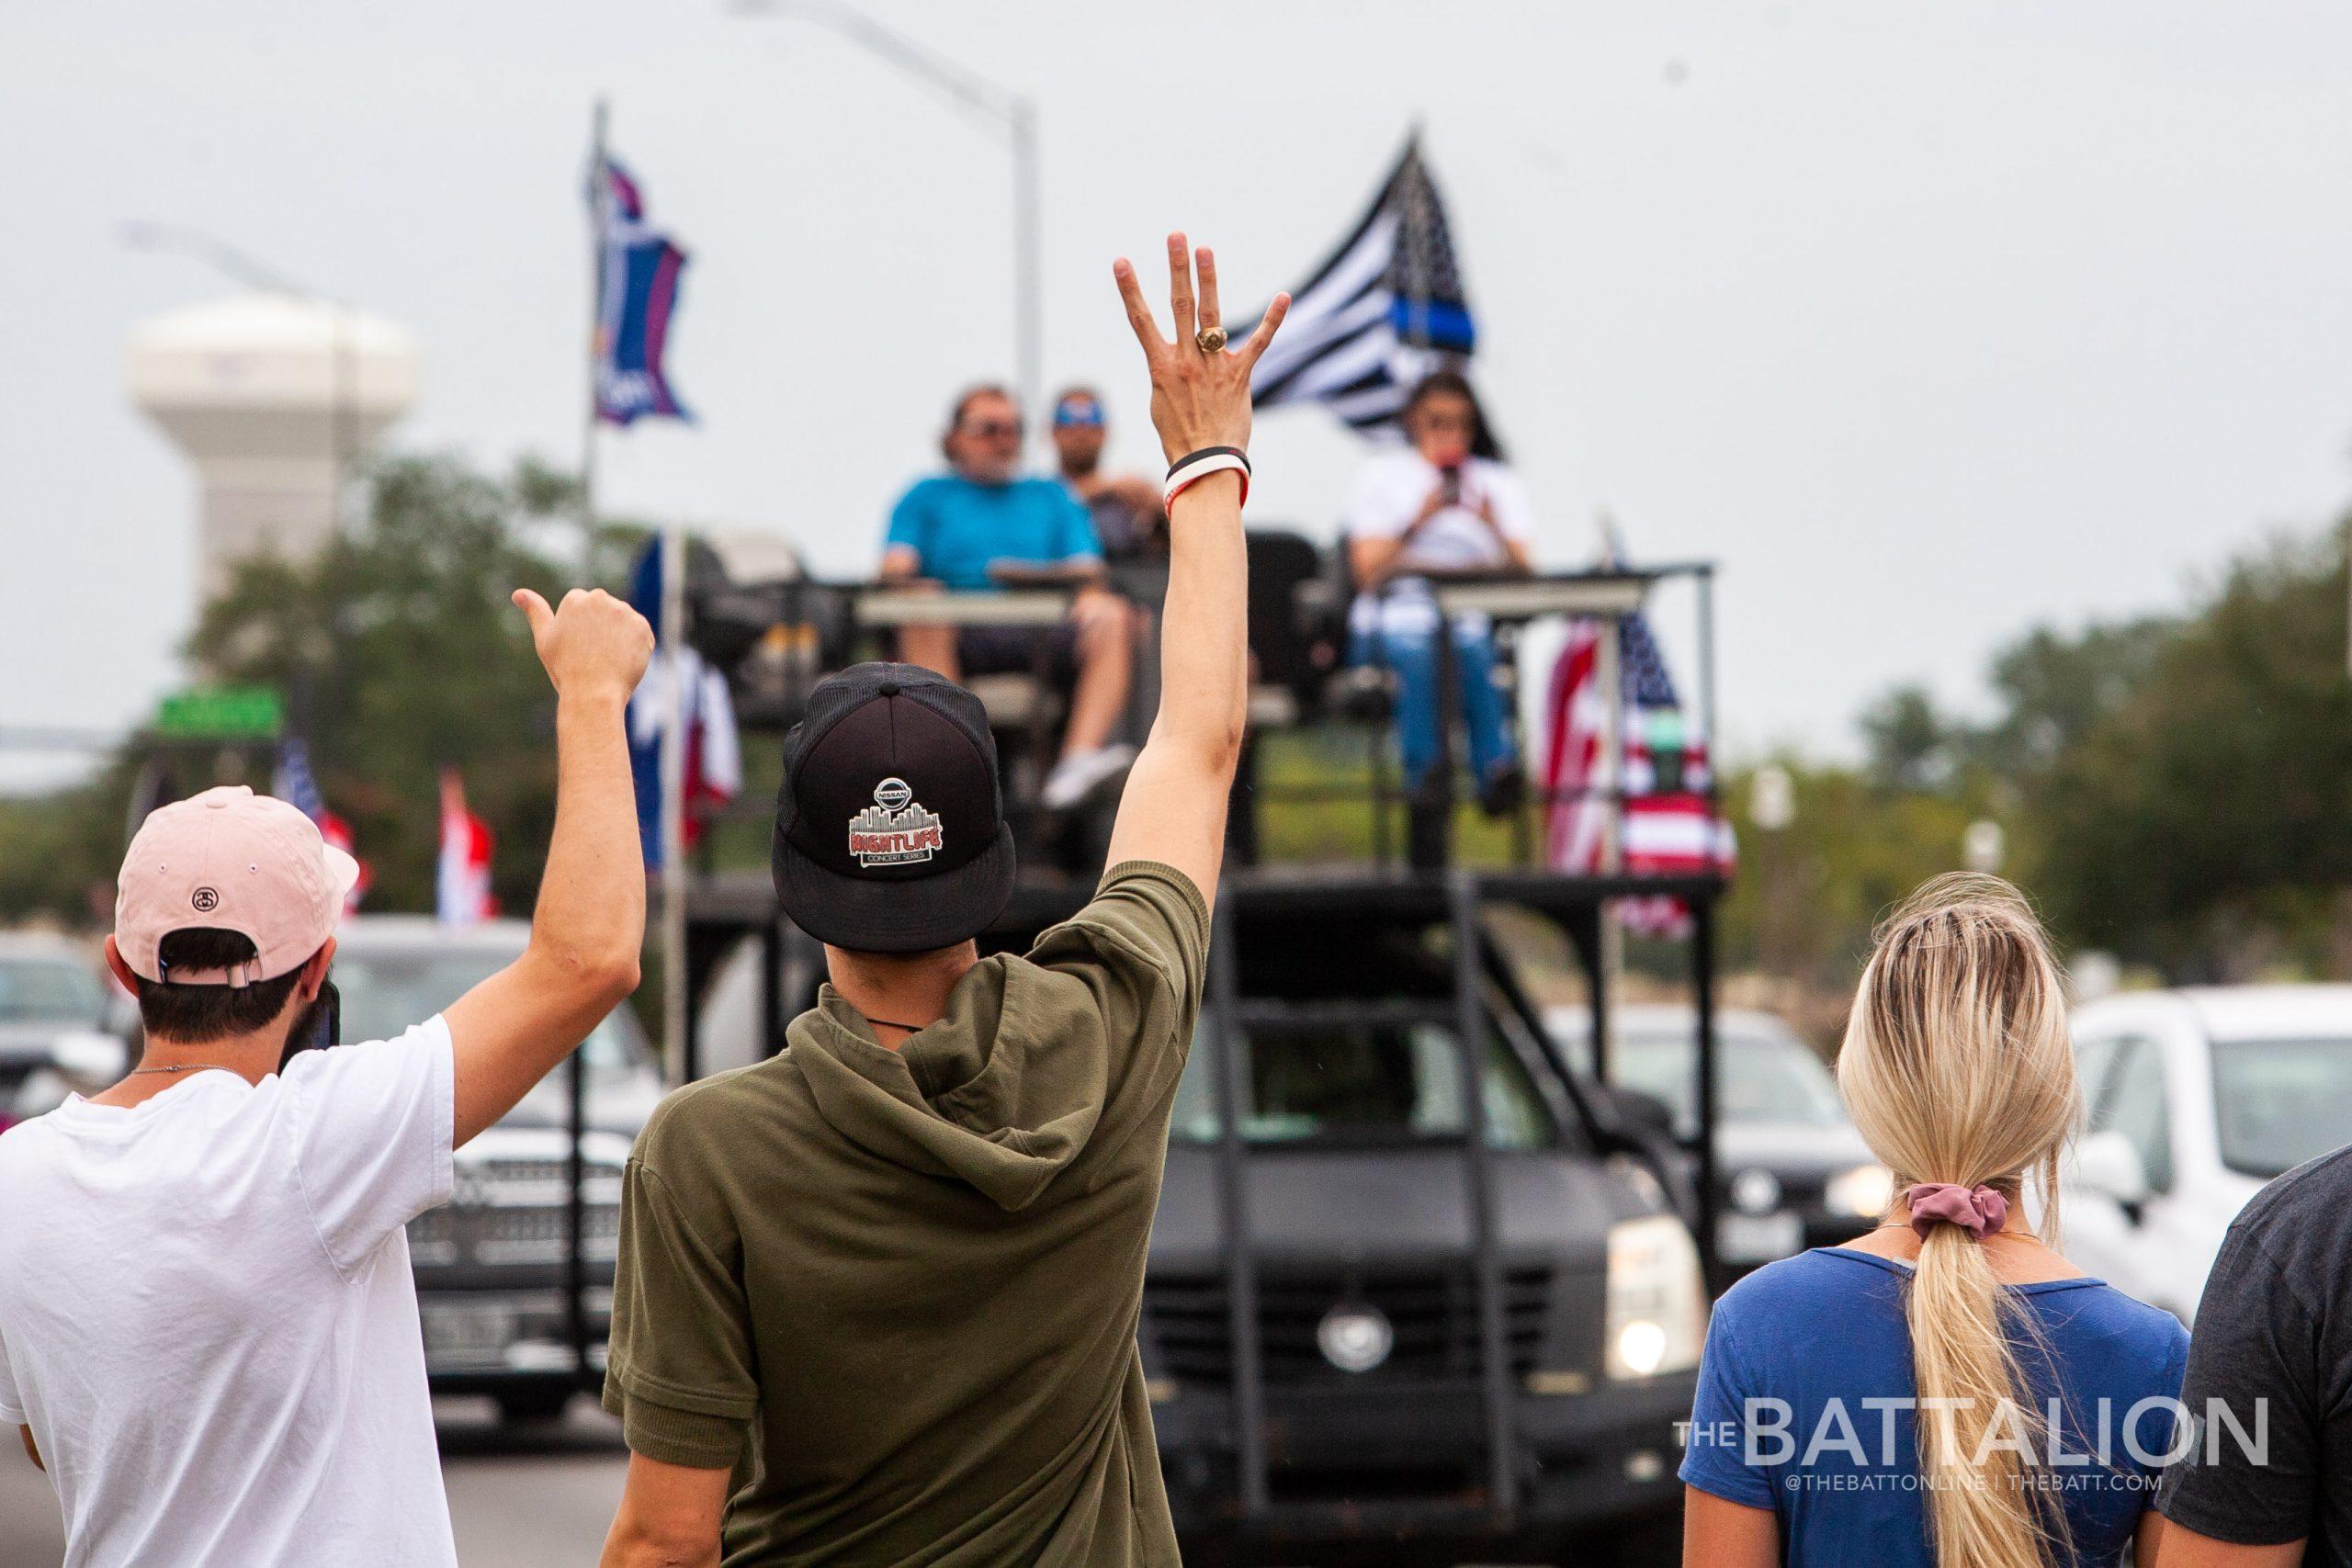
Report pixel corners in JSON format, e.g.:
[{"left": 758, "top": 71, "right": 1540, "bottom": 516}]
[{"left": 334, "top": 915, "right": 661, "bottom": 1420}]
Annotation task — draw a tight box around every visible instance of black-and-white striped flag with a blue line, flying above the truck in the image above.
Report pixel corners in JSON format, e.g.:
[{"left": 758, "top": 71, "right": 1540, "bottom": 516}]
[{"left": 1238, "top": 131, "right": 1477, "bottom": 433}]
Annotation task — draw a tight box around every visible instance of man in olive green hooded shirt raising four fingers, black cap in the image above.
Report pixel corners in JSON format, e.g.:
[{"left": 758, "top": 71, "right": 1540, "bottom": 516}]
[{"left": 588, "top": 235, "right": 1289, "bottom": 1568}]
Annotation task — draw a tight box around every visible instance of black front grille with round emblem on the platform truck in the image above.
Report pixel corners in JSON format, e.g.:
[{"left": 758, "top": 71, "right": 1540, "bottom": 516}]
[{"left": 1143, "top": 1262, "right": 1553, "bottom": 1384}]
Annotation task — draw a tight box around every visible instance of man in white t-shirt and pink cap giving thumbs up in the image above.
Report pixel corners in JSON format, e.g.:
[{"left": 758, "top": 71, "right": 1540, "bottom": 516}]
[{"left": 0, "top": 592, "right": 654, "bottom": 1568}]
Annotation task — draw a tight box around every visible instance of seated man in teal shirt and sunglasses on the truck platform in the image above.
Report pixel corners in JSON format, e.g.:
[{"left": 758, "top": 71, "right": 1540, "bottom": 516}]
[{"left": 882, "top": 386, "right": 1136, "bottom": 811}]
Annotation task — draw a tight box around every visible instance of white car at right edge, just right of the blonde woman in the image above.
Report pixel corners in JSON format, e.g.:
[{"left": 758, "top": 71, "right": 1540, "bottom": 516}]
[{"left": 2061, "top": 985, "right": 2352, "bottom": 1321}]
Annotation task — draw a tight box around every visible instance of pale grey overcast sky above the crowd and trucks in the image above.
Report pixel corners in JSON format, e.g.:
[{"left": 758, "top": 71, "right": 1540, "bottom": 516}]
[{"left": 0, "top": 0, "right": 2352, "bottom": 778}]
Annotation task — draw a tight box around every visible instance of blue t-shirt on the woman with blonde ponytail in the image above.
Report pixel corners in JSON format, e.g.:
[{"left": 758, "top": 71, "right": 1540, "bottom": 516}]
[{"left": 1681, "top": 1246, "right": 2189, "bottom": 1568}]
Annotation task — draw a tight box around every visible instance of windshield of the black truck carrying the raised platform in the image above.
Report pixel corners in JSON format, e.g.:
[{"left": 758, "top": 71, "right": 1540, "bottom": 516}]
[{"left": 1173, "top": 1016, "right": 1550, "bottom": 1149}]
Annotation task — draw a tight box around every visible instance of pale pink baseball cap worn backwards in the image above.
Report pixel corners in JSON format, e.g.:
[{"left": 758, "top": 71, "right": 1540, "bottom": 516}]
[{"left": 115, "top": 785, "right": 360, "bottom": 985}]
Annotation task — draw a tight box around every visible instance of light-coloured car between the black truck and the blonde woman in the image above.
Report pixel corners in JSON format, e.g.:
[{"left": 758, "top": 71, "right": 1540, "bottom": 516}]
[{"left": 1545, "top": 1004, "right": 1894, "bottom": 1277}]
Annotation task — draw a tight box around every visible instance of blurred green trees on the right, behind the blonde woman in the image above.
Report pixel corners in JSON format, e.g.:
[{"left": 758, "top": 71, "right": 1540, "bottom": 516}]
[{"left": 1729, "top": 520, "right": 2352, "bottom": 983}]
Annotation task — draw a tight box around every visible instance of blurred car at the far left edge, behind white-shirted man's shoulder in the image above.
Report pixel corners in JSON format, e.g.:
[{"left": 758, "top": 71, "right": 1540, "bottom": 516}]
[{"left": 0, "top": 931, "right": 127, "bottom": 1128}]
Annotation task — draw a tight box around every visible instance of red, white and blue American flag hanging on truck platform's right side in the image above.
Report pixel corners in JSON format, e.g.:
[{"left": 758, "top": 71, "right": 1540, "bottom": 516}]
[{"left": 1543, "top": 614, "right": 1736, "bottom": 936}]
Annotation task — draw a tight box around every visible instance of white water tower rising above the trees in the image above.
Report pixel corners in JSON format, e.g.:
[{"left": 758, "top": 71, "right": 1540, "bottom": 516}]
[{"left": 130, "top": 291, "right": 421, "bottom": 597}]
